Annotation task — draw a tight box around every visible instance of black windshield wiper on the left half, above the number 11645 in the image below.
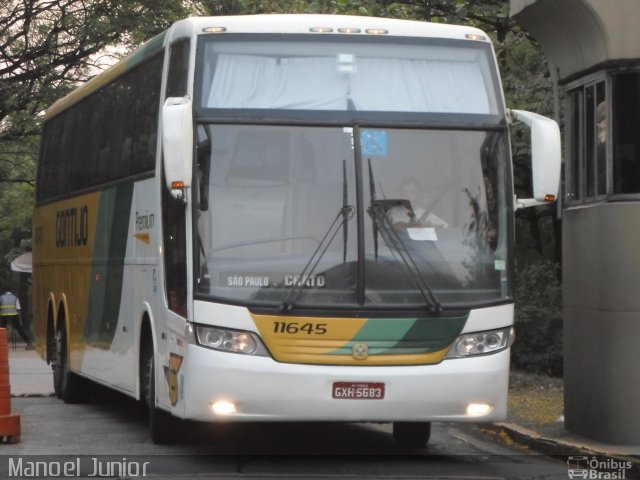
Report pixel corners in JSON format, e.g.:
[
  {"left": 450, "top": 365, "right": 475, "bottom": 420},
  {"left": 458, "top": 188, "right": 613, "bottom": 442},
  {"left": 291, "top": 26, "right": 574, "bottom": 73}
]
[{"left": 278, "top": 160, "right": 355, "bottom": 313}]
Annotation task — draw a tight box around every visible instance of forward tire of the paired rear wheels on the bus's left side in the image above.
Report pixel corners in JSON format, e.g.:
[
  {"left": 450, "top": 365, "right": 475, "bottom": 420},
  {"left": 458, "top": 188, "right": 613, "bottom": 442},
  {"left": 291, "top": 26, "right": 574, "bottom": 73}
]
[{"left": 51, "top": 322, "right": 91, "bottom": 403}]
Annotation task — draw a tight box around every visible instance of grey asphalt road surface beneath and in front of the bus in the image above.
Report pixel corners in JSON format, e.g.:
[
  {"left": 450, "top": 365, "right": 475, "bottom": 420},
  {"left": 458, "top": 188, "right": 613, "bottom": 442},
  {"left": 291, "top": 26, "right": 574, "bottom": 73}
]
[{"left": 0, "top": 397, "right": 568, "bottom": 480}]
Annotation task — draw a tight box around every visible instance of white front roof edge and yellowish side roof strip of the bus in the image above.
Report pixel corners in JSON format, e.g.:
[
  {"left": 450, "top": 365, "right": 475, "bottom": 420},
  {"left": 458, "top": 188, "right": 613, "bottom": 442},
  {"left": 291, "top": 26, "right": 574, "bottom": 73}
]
[{"left": 45, "top": 14, "right": 490, "bottom": 120}]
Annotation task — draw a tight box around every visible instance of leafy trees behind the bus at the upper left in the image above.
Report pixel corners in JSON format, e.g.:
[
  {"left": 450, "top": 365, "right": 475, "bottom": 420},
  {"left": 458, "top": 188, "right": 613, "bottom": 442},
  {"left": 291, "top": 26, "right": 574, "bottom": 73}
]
[{"left": 0, "top": 0, "right": 204, "bottom": 280}]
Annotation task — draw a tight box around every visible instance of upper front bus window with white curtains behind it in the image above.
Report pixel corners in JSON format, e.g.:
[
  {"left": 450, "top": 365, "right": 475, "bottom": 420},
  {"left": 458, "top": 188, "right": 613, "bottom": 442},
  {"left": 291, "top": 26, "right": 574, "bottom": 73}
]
[{"left": 199, "top": 35, "right": 499, "bottom": 115}]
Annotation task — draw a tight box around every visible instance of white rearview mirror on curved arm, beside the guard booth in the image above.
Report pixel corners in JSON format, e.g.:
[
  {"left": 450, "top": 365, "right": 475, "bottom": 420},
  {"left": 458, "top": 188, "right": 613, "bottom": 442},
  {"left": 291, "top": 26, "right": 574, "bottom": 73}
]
[{"left": 510, "top": 110, "right": 561, "bottom": 208}]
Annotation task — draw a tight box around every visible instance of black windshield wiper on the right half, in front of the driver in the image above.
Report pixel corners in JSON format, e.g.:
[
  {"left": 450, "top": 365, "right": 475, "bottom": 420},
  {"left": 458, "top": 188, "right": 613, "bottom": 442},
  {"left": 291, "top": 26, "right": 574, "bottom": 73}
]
[{"left": 368, "top": 165, "right": 442, "bottom": 313}]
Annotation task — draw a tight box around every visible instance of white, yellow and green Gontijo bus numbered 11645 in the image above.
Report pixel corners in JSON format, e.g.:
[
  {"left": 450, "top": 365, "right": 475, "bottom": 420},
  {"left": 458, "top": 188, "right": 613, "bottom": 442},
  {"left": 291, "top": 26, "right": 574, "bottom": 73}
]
[{"left": 33, "top": 15, "right": 560, "bottom": 446}]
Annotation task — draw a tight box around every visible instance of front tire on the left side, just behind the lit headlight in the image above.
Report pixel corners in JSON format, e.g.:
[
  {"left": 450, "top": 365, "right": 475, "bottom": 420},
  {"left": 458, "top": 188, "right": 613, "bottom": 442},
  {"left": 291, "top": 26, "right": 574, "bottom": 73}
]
[{"left": 142, "top": 345, "right": 176, "bottom": 445}]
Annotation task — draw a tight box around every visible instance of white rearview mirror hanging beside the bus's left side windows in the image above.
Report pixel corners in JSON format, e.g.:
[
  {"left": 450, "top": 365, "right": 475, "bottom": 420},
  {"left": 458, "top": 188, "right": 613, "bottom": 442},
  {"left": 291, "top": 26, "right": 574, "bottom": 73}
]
[{"left": 162, "top": 97, "right": 193, "bottom": 198}]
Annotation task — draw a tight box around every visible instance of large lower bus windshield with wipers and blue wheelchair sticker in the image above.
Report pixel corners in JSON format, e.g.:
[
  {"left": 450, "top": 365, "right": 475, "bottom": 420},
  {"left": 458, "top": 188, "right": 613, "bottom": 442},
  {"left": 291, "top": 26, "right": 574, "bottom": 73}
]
[{"left": 194, "top": 123, "right": 510, "bottom": 308}]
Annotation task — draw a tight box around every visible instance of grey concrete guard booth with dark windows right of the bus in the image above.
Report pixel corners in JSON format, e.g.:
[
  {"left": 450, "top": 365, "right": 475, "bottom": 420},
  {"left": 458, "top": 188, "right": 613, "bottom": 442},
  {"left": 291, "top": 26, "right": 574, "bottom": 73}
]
[{"left": 510, "top": 0, "right": 640, "bottom": 445}]
